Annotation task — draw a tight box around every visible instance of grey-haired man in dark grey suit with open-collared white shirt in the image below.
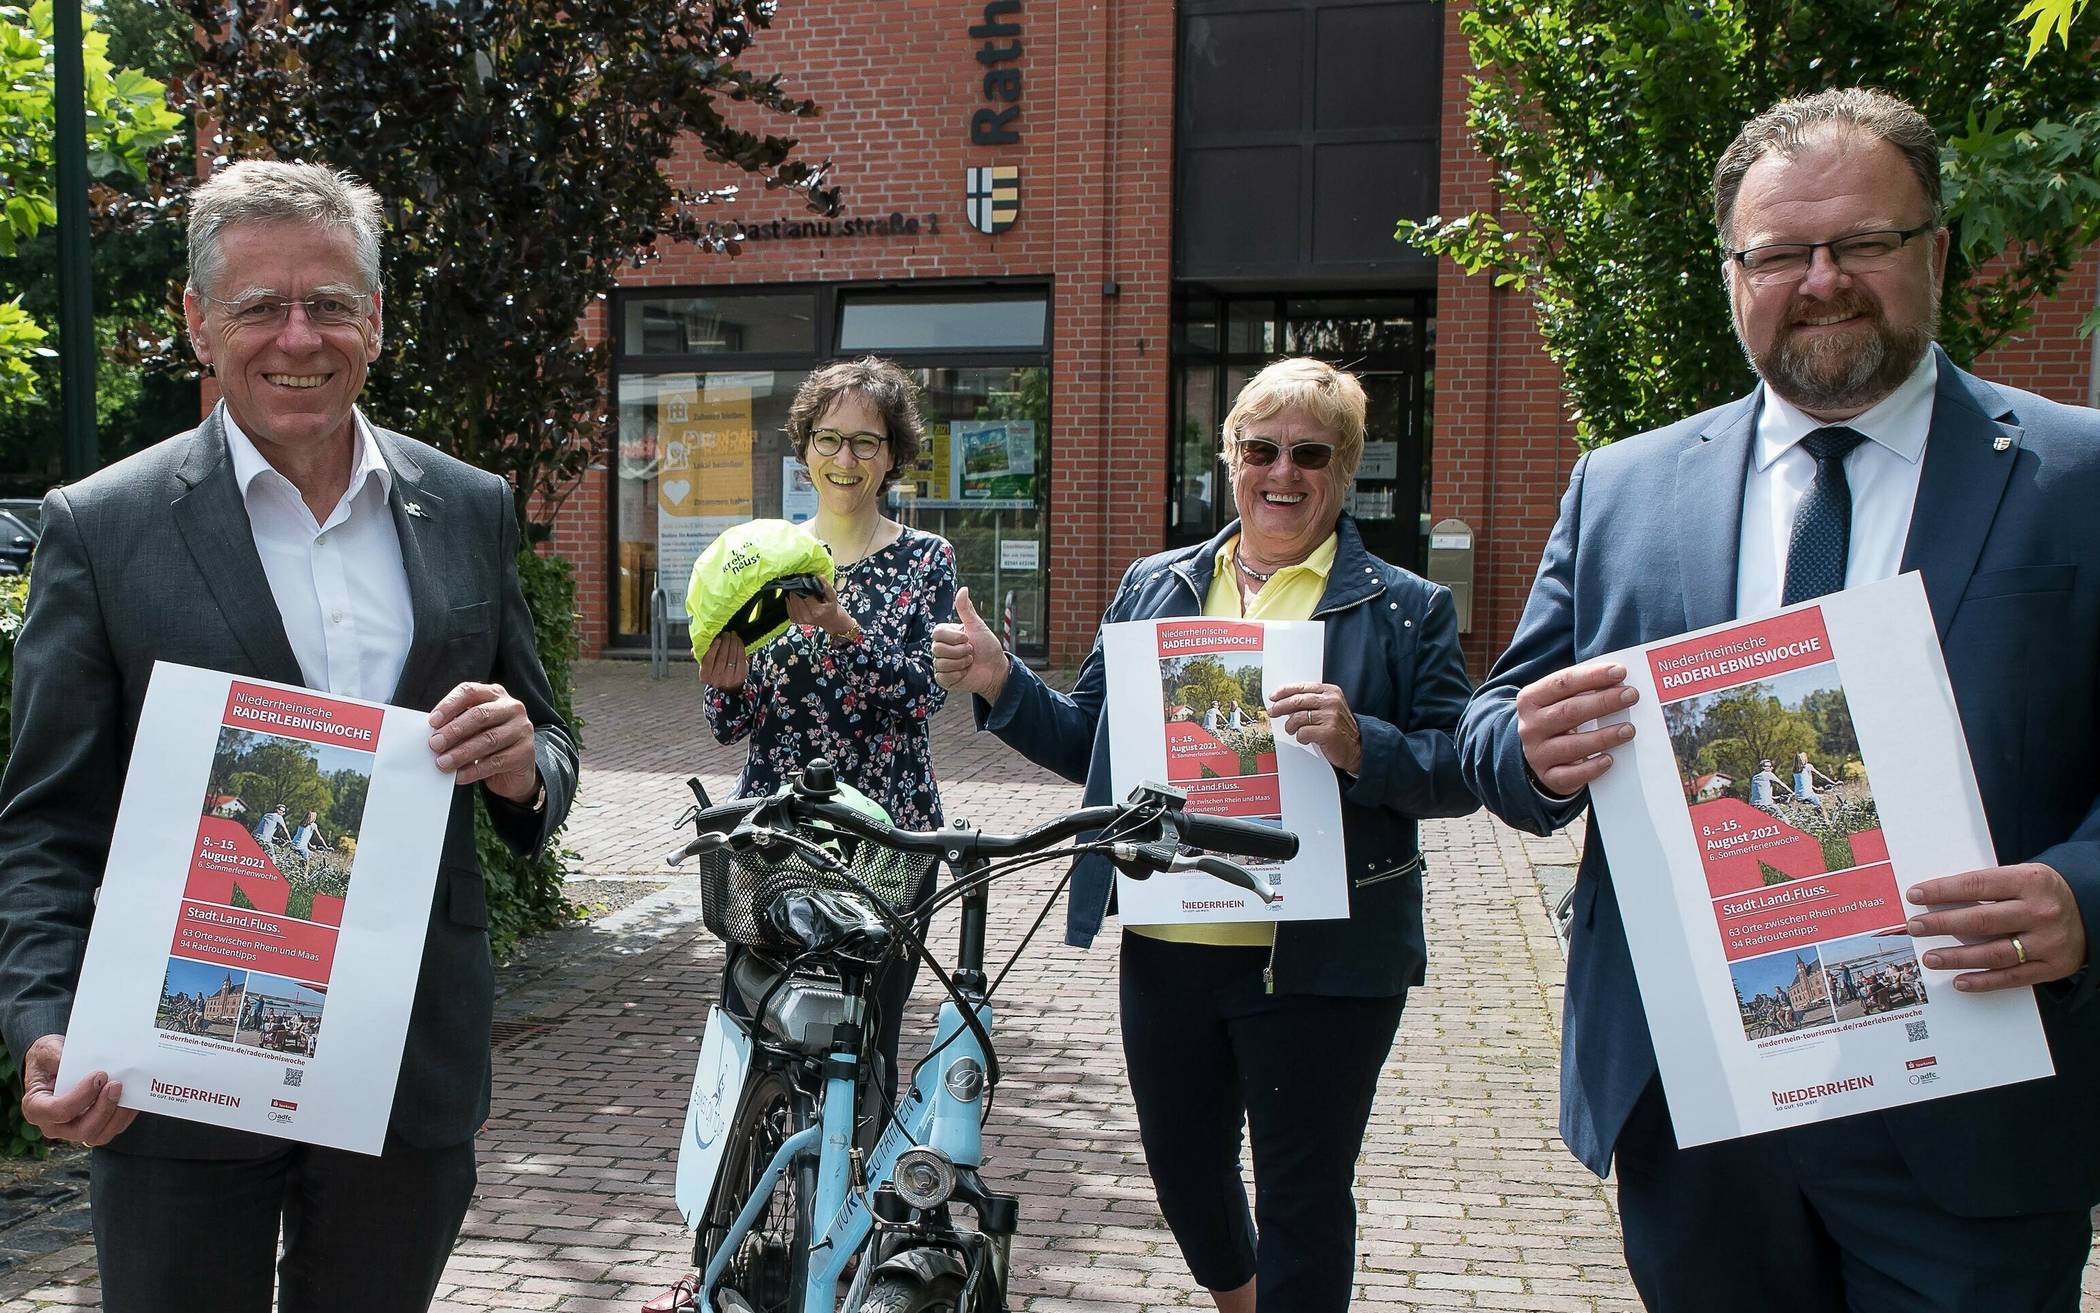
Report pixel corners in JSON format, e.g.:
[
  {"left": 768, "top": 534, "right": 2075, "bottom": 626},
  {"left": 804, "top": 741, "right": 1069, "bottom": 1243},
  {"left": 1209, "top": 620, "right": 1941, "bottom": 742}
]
[{"left": 0, "top": 162, "right": 575, "bottom": 1313}]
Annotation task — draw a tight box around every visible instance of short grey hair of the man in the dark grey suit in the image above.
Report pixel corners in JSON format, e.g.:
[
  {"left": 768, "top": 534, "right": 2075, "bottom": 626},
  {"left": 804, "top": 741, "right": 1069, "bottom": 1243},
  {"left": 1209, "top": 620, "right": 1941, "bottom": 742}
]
[{"left": 189, "top": 160, "right": 384, "bottom": 294}]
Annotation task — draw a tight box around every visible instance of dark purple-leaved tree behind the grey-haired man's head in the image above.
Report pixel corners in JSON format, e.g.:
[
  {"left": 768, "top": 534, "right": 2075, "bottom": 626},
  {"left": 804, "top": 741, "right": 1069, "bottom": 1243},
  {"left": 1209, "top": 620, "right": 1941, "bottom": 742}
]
[{"left": 185, "top": 0, "right": 838, "bottom": 523}]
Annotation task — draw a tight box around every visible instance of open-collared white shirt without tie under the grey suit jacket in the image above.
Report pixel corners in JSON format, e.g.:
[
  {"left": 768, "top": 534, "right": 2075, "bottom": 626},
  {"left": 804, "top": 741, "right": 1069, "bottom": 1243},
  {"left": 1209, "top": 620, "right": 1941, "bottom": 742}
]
[{"left": 225, "top": 412, "right": 416, "bottom": 702}]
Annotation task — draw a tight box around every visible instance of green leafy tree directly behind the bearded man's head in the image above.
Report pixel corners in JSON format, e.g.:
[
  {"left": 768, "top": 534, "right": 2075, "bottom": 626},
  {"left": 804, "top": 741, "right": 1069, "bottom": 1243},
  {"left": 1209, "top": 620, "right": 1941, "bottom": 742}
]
[{"left": 1394, "top": 0, "right": 2100, "bottom": 445}]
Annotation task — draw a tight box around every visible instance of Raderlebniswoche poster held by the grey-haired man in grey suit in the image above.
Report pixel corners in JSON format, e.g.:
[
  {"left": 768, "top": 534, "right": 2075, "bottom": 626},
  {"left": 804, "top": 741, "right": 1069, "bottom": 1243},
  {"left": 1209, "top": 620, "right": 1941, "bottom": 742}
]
[{"left": 59, "top": 662, "right": 454, "bottom": 1153}]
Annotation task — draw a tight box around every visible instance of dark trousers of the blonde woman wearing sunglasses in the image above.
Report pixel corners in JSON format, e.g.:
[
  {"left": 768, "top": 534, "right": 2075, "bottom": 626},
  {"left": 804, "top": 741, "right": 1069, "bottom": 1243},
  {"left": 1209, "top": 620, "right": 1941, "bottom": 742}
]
[{"left": 1121, "top": 931, "right": 1405, "bottom": 1313}]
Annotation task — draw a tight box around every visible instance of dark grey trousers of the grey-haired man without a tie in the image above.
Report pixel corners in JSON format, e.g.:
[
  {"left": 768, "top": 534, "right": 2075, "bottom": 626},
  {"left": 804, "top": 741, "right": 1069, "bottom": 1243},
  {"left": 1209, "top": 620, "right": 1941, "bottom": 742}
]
[{"left": 88, "top": 1137, "right": 475, "bottom": 1313}]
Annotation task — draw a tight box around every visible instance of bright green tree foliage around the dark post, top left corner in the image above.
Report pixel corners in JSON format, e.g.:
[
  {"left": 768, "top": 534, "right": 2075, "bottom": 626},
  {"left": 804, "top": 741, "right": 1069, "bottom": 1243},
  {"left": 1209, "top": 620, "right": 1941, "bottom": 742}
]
[{"left": 0, "top": 0, "right": 181, "bottom": 410}]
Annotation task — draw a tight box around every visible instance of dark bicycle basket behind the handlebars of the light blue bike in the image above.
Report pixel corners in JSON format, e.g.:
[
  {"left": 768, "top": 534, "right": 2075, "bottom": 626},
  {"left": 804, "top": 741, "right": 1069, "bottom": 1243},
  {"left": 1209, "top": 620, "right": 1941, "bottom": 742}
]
[{"left": 695, "top": 798, "right": 935, "bottom": 947}]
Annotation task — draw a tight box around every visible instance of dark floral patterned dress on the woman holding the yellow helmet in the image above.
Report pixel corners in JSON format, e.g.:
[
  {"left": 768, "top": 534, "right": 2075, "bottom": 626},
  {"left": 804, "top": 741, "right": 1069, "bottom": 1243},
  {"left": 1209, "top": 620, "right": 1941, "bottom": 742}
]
[{"left": 706, "top": 525, "right": 956, "bottom": 830}]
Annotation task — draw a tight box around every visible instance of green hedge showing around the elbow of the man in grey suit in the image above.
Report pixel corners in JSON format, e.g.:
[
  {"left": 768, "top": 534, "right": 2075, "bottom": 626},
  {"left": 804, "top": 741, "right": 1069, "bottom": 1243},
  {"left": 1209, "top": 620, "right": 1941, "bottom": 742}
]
[{"left": 475, "top": 548, "right": 582, "bottom": 958}]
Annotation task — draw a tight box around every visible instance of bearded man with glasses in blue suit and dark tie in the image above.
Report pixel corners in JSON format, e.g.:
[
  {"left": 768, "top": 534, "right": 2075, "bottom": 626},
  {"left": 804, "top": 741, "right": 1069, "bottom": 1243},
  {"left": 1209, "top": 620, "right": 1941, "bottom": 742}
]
[{"left": 1460, "top": 90, "right": 2100, "bottom": 1313}]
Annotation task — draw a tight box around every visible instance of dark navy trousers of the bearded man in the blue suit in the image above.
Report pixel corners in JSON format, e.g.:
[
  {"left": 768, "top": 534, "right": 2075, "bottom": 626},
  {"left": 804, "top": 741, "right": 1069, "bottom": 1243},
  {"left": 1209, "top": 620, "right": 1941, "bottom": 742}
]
[{"left": 1617, "top": 1082, "right": 2092, "bottom": 1313}]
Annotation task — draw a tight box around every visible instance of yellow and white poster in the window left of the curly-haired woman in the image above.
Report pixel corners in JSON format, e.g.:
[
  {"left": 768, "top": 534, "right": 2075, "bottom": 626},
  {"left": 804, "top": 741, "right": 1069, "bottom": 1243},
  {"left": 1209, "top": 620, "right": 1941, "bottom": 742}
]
[{"left": 657, "top": 378, "right": 756, "bottom": 611}]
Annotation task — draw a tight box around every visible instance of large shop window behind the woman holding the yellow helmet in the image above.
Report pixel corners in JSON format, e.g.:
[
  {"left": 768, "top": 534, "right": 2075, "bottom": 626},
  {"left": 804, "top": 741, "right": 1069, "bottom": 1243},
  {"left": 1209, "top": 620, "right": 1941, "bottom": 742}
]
[{"left": 609, "top": 288, "right": 1050, "bottom": 655}]
